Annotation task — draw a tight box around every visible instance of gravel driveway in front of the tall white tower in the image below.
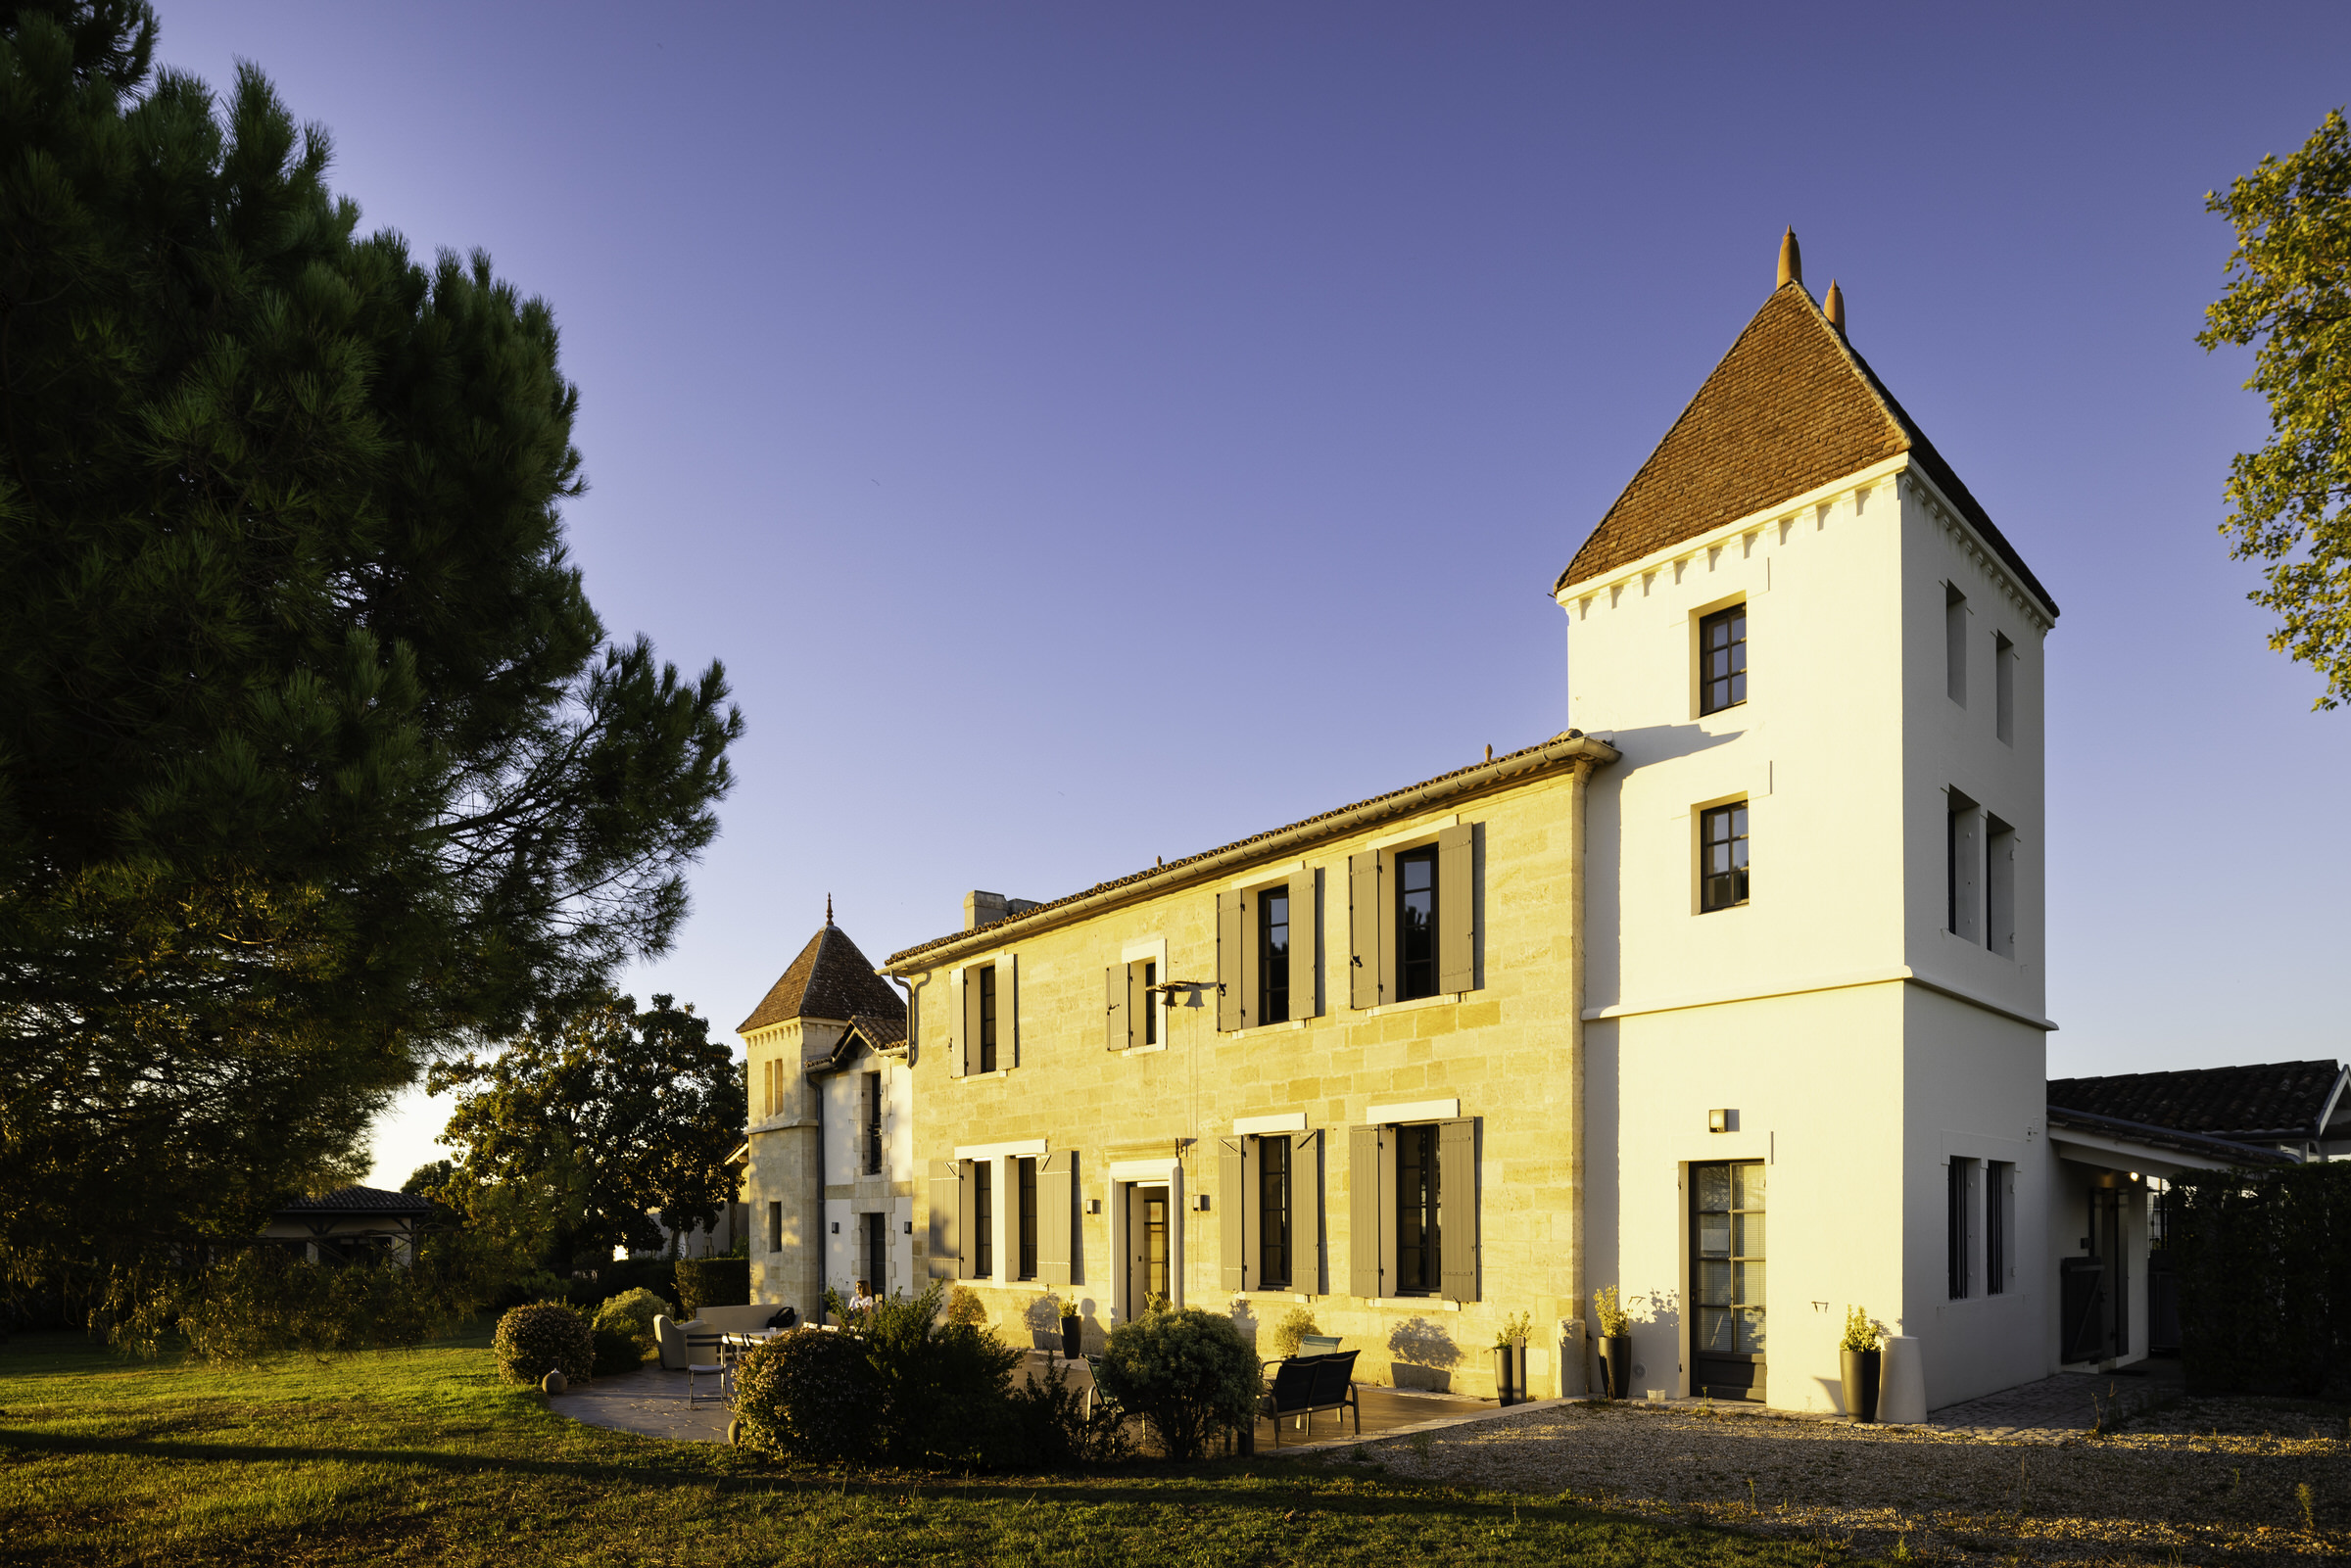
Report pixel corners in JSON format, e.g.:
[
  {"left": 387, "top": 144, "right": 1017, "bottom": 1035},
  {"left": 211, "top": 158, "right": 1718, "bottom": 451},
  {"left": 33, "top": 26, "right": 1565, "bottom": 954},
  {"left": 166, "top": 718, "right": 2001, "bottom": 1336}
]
[{"left": 1333, "top": 1399, "right": 2351, "bottom": 1563}]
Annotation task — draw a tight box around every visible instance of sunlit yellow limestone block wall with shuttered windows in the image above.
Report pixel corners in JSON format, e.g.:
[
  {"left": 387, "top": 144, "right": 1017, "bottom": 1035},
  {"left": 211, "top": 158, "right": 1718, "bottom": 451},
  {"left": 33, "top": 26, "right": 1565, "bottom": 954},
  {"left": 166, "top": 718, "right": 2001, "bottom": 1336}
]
[{"left": 905, "top": 769, "right": 1582, "bottom": 1392}]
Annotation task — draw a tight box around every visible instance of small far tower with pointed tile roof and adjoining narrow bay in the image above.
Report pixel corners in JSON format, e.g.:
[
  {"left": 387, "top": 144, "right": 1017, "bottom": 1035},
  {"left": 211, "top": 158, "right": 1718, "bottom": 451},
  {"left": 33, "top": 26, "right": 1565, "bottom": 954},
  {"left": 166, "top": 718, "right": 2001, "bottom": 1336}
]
[{"left": 736, "top": 912, "right": 912, "bottom": 1321}]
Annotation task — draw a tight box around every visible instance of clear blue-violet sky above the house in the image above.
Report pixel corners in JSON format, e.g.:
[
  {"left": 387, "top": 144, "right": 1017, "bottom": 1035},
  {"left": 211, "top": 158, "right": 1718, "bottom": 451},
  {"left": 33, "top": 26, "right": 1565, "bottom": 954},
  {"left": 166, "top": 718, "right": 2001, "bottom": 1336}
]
[{"left": 147, "top": 0, "right": 2351, "bottom": 1185}]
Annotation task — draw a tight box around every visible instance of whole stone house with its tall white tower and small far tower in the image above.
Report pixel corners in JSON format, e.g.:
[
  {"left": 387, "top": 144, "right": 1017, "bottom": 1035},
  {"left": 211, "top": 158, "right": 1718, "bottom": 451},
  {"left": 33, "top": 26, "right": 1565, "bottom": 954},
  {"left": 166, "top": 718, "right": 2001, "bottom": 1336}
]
[{"left": 743, "top": 235, "right": 2331, "bottom": 1410}]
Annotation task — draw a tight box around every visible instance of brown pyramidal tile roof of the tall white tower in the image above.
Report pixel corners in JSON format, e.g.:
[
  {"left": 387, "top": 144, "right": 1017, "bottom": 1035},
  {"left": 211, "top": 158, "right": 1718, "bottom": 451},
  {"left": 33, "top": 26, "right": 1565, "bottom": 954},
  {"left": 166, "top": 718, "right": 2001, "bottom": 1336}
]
[{"left": 1552, "top": 280, "right": 2057, "bottom": 616}]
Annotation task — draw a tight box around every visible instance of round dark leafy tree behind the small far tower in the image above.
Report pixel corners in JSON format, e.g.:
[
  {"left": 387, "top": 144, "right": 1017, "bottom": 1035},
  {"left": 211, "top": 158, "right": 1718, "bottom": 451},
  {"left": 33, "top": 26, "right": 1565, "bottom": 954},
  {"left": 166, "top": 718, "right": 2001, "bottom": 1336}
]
[{"left": 428, "top": 994, "right": 750, "bottom": 1267}]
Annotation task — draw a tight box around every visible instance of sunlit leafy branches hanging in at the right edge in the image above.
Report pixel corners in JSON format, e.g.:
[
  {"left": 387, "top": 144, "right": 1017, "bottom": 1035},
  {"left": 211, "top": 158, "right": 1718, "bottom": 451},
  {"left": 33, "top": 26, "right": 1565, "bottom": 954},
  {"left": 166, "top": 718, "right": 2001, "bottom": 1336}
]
[{"left": 2196, "top": 108, "right": 2351, "bottom": 707}]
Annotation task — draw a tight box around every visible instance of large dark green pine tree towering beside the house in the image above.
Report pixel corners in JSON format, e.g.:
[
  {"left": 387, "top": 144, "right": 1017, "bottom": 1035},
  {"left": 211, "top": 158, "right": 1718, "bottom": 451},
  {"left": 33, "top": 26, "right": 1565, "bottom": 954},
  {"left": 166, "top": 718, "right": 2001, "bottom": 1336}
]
[{"left": 0, "top": 0, "right": 741, "bottom": 1279}]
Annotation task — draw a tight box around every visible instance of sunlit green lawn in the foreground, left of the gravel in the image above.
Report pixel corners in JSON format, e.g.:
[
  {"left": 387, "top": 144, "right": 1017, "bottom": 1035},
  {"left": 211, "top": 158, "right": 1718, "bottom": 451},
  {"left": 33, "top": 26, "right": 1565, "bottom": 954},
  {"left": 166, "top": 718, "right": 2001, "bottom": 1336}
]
[{"left": 0, "top": 1335, "right": 1841, "bottom": 1568}]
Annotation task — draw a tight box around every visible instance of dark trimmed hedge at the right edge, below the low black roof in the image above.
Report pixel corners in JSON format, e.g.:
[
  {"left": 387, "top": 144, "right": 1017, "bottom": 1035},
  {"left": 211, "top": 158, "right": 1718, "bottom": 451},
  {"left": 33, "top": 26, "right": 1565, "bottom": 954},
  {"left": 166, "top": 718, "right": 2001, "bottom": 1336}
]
[{"left": 2168, "top": 1162, "right": 2351, "bottom": 1399}]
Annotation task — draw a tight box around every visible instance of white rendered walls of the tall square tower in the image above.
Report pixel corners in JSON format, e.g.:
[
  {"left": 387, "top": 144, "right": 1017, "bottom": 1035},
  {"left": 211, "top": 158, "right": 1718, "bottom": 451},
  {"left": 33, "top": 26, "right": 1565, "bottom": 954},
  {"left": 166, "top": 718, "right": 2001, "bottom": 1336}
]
[{"left": 1561, "top": 458, "right": 2052, "bottom": 1410}]
